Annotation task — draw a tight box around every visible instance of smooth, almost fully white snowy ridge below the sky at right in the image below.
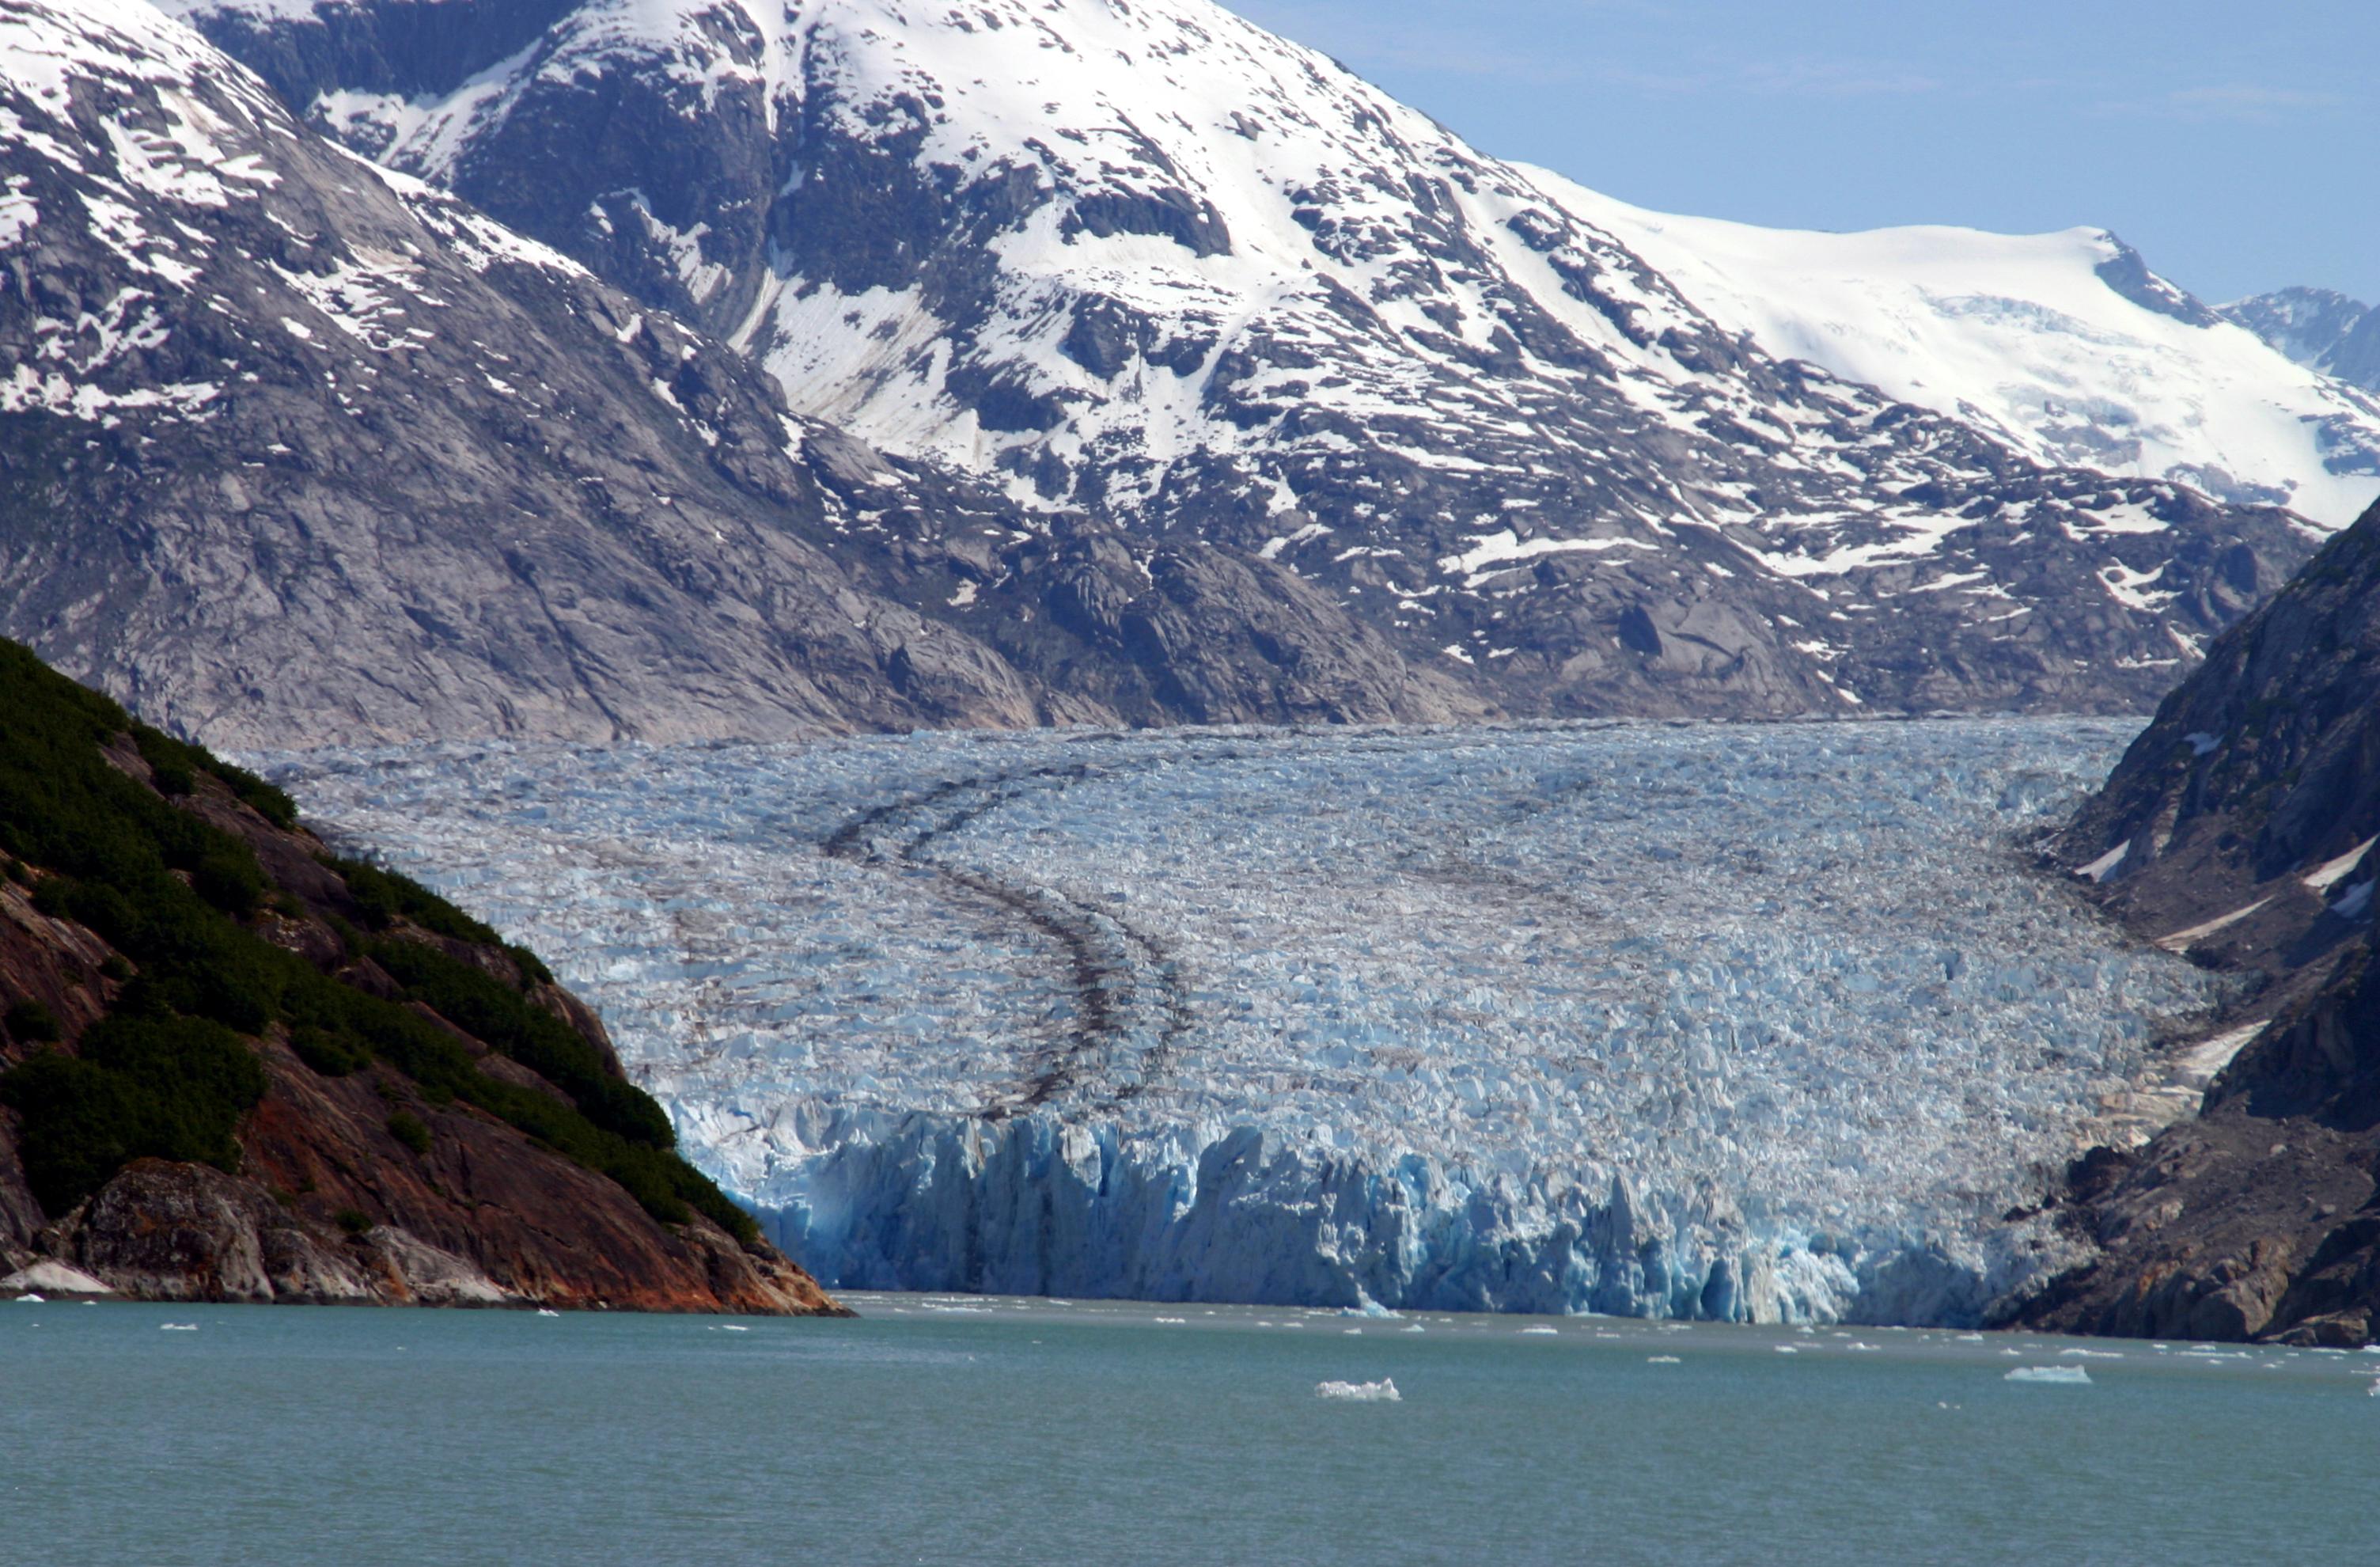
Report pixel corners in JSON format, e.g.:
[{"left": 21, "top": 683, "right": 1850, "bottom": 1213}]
[{"left": 1537, "top": 182, "right": 2380, "bottom": 529}]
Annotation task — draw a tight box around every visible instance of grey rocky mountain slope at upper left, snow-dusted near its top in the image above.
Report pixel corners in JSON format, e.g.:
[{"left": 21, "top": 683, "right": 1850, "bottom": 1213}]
[{"left": 0, "top": 0, "right": 1483, "bottom": 743}]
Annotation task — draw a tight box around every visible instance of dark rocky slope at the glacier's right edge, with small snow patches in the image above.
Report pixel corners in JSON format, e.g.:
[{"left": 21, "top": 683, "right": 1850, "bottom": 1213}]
[{"left": 2033, "top": 507, "right": 2380, "bottom": 1343}]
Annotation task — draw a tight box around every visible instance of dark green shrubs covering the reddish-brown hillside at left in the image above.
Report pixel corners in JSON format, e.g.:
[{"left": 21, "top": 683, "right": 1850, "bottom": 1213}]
[{"left": 0, "top": 640, "right": 757, "bottom": 1241}]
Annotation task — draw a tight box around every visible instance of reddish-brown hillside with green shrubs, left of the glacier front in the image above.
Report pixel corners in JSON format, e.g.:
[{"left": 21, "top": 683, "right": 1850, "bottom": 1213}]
[{"left": 0, "top": 643, "right": 840, "bottom": 1312}]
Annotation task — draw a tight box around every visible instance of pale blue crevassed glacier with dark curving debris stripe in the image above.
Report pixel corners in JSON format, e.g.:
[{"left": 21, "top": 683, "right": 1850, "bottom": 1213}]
[{"left": 250, "top": 719, "right": 2220, "bottom": 1324}]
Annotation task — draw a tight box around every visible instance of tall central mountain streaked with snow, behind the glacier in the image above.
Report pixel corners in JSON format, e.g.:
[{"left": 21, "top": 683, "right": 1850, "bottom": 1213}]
[{"left": 174, "top": 0, "right": 2314, "bottom": 715}]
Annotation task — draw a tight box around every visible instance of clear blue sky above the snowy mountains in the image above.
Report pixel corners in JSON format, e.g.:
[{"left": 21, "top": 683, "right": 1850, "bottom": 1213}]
[{"left": 1226, "top": 0, "right": 2380, "bottom": 302}]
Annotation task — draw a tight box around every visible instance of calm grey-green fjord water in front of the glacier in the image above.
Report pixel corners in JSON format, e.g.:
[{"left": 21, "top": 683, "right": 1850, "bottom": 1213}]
[{"left": 0, "top": 1296, "right": 2380, "bottom": 1565}]
